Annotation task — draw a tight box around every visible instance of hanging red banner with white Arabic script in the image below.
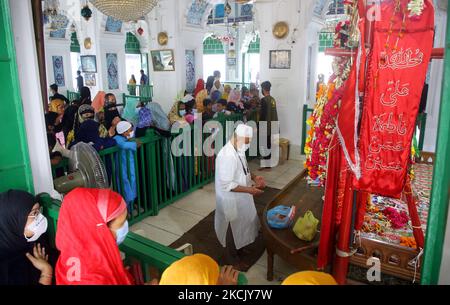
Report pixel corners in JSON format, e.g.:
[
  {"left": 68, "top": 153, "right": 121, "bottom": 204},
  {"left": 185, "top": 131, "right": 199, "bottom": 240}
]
[{"left": 354, "top": 0, "right": 434, "bottom": 198}]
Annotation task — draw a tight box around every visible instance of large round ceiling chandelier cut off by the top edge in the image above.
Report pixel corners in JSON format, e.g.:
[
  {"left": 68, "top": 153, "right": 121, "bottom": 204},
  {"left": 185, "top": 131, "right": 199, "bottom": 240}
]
[{"left": 90, "top": 0, "right": 159, "bottom": 22}]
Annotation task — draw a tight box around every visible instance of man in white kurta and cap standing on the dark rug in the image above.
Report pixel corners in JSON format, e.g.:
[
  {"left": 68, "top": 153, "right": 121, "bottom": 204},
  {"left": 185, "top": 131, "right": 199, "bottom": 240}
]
[{"left": 215, "top": 124, "right": 265, "bottom": 270}]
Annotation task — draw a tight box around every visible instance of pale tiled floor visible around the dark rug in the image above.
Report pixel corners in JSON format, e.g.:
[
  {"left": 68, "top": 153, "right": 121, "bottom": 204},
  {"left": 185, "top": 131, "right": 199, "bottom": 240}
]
[{"left": 131, "top": 160, "right": 303, "bottom": 285}]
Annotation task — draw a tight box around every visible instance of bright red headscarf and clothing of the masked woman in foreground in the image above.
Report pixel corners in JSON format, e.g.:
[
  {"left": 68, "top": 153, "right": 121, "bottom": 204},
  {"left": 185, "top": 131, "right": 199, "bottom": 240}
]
[{"left": 56, "top": 188, "right": 132, "bottom": 285}]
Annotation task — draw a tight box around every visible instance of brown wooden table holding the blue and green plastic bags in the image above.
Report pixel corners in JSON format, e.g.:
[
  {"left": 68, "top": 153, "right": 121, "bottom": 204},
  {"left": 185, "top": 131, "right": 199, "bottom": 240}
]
[{"left": 262, "top": 171, "right": 323, "bottom": 281}]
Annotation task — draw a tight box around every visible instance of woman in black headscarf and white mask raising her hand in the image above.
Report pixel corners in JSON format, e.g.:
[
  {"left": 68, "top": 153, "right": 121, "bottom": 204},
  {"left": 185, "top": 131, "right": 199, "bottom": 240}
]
[{"left": 0, "top": 190, "right": 54, "bottom": 285}]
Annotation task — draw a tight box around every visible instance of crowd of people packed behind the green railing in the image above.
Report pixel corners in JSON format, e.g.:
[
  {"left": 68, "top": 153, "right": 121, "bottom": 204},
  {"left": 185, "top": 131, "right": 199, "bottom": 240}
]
[{"left": 45, "top": 73, "right": 260, "bottom": 170}]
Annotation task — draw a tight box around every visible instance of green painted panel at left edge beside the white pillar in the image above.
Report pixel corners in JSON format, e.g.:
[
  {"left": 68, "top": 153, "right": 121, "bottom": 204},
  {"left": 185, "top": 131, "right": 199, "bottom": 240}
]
[{"left": 0, "top": 0, "right": 33, "bottom": 193}]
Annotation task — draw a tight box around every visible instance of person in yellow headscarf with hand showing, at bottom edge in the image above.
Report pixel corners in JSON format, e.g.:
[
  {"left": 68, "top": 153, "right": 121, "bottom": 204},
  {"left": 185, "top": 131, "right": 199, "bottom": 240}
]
[{"left": 159, "top": 254, "right": 239, "bottom": 285}]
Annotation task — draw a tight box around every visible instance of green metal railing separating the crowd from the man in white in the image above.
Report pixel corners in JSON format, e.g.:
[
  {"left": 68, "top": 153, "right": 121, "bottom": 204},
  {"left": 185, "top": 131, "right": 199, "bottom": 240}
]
[{"left": 52, "top": 114, "right": 243, "bottom": 224}]
